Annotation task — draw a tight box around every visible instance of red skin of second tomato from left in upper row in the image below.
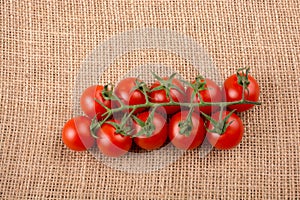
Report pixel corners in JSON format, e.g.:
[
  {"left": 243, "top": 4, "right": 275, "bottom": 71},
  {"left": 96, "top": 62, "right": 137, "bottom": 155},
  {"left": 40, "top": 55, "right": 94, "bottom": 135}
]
[{"left": 114, "top": 77, "right": 146, "bottom": 113}]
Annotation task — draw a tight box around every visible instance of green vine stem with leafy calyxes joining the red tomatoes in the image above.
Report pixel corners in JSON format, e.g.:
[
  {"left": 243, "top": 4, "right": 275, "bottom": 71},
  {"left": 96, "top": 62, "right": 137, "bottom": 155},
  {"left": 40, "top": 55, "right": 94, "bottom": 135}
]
[{"left": 90, "top": 68, "right": 261, "bottom": 139}]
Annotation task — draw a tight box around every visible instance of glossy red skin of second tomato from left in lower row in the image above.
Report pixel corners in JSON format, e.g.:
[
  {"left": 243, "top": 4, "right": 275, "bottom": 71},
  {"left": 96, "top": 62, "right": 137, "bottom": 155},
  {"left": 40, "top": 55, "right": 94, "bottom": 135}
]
[{"left": 97, "top": 120, "right": 132, "bottom": 157}]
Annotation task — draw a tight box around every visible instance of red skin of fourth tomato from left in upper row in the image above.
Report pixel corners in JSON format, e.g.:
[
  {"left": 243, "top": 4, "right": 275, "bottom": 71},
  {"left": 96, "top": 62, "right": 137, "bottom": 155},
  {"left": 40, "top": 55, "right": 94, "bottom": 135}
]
[{"left": 186, "top": 78, "right": 222, "bottom": 115}]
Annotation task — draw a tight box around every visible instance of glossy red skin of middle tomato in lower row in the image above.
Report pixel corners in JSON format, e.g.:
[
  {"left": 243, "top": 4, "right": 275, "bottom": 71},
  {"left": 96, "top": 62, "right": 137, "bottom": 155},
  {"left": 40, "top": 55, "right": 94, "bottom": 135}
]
[{"left": 134, "top": 111, "right": 168, "bottom": 150}]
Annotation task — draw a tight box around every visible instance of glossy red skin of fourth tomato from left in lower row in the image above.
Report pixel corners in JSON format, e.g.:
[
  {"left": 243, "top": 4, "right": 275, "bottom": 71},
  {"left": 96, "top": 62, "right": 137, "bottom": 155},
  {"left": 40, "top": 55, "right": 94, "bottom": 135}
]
[{"left": 169, "top": 111, "right": 206, "bottom": 150}]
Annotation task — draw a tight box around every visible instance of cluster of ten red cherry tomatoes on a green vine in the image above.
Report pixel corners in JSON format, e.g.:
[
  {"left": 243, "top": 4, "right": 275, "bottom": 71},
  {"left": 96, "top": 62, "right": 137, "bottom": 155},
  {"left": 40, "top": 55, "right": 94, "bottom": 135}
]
[{"left": 62, "top": 69, "right": 259, "bottom": 157}]
